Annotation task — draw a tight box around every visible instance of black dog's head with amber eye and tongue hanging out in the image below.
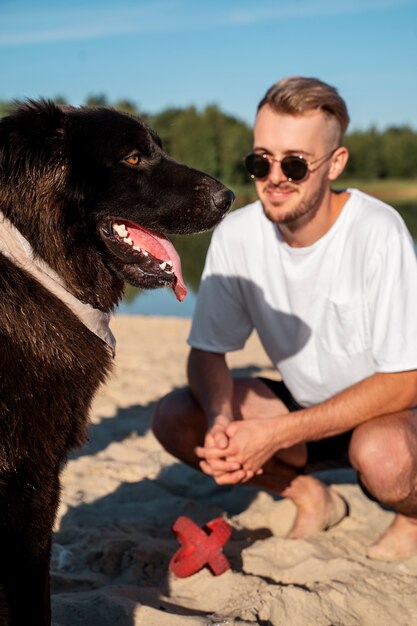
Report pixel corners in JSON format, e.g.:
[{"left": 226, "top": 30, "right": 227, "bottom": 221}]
[{"left": 0, "top": 101, "right": 234, "bottom": 308}]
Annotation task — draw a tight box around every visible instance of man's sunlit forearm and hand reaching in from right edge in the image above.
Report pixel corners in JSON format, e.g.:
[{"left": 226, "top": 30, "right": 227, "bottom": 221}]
[{"left": 216, "top": 370, "right": 417, "bottom": 472}]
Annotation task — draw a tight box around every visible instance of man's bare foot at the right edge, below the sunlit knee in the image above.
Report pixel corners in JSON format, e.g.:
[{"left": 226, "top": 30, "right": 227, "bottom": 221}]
[{"left": 367, "top": 514, "right": 417, "bottom": 561}]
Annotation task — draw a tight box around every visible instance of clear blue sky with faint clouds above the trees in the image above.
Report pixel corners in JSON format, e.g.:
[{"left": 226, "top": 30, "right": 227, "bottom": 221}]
[{"left": 0, "top": 0, "right": 417, "bottom": 130}]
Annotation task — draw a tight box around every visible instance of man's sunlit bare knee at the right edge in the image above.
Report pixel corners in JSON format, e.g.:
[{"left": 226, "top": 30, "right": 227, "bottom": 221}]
[{"left": 349, "top": 418, "right": 417, "bottom": 504}]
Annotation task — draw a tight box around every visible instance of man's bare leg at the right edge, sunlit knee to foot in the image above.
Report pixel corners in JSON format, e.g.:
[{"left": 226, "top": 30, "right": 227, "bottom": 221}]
[{"left": 350, "top": 409, "right": 417, "bottom": 561}]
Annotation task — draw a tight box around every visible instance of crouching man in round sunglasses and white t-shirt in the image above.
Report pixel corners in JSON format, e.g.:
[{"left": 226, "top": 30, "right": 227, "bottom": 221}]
[{"left": 153, "top": 77, "right": 417, "bottom": 560}]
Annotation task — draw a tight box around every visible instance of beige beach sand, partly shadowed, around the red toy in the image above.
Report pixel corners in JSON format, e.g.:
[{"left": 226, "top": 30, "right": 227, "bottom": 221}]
[{"left": 51, "top": 316, "right": 417, "bottom": 626}]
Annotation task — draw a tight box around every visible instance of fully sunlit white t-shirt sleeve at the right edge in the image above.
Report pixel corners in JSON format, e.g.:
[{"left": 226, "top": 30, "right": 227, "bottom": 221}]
[{"left": 367, "top": 233, "right": 417, "bottom": 372}]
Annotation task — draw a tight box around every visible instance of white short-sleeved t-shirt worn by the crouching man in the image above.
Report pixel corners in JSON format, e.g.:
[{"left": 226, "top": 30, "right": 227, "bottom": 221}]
[{"left": 188, "top": 189, "right": 417, "bottom": 406}]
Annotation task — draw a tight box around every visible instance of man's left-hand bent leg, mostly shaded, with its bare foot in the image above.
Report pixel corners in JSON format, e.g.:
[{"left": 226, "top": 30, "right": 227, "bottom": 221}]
[{"left": 152, "top": 378, "right": 346, "bottom": 538}]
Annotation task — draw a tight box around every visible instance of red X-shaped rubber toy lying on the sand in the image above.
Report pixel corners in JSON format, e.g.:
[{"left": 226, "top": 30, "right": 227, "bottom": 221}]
[{"left": 169, "top": 515, "right": 232, "bottom": 578}]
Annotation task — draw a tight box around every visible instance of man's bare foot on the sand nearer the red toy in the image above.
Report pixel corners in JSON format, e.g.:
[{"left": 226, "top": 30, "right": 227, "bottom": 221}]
[{"left": 282, "top": 476, "right": 348, "bottom": 539}]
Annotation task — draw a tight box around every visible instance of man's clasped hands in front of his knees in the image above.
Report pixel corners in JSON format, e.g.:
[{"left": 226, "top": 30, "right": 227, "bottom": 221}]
[{"left": 195, "top": 415, "right": 277, "bottom": 485}]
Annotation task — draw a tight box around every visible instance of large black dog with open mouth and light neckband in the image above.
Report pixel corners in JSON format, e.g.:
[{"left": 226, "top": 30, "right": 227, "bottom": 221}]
[{"left": 0, "top": 102, "right": 233, "bottom": 626}]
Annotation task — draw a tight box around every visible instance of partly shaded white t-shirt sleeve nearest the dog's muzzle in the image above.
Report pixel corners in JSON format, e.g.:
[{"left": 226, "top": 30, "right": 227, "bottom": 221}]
[{"left": 188, "top": 223, "right": 253, "bottom": 353}]
